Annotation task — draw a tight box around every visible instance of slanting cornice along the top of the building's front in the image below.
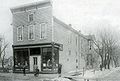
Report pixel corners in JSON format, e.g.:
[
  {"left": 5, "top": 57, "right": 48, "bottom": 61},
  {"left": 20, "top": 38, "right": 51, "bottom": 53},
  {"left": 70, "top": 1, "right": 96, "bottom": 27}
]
[{"left": 10, "top": 0, "right": 52, "bottom": 11}]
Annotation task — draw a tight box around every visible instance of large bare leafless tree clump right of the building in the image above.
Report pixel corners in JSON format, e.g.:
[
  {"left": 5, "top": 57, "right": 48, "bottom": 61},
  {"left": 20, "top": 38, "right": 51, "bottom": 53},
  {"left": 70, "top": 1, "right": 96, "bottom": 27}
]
[{"left": 93, "top": 29, "right": 119, "bottom": 70}]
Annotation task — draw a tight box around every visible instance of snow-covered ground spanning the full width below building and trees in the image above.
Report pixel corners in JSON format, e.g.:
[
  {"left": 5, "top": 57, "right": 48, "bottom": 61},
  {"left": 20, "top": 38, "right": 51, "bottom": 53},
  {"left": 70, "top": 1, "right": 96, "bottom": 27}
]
[{"left": 0, "top": 67, "right": 120, "bottom": 81}]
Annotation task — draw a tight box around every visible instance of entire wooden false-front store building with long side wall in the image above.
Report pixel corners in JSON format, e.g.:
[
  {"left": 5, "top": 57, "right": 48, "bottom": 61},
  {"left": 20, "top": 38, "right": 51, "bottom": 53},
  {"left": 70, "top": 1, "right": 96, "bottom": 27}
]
[{"left": 11, "top": 0, "right": 94, "bottom": 73}]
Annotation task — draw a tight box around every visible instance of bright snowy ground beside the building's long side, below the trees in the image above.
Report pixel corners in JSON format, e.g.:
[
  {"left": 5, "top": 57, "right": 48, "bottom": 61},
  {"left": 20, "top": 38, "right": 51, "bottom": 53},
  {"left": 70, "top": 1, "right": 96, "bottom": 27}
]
[{"left": 56, "top": 67, "right": 120, "bottom": 81}]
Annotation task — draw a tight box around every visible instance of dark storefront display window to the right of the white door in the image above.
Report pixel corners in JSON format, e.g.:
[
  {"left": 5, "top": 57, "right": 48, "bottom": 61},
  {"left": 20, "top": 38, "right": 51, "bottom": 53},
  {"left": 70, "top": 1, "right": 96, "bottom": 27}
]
[{"left": 42, "top": 47, "right": 59, "bottom": 71}]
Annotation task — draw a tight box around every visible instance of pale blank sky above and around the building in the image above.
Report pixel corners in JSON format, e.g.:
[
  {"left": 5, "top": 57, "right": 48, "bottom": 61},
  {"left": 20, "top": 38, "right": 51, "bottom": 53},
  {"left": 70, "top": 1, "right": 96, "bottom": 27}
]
[{"left": 0, "top": 0, "right": 120, "bottom": 56}]
